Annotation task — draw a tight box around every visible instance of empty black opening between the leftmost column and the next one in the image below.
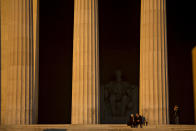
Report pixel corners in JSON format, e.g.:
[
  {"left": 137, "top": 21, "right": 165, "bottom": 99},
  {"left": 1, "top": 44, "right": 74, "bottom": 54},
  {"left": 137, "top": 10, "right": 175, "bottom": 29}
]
[{"left": 38, "top": 0, "right": 73, "bottom": 124}]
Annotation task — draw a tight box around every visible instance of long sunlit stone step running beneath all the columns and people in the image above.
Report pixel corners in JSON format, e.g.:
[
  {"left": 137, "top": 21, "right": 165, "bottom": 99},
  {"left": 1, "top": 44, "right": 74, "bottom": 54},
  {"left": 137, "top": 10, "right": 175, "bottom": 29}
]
[{"left": 0, "top": 124, "right": 196, "bottom": 131}]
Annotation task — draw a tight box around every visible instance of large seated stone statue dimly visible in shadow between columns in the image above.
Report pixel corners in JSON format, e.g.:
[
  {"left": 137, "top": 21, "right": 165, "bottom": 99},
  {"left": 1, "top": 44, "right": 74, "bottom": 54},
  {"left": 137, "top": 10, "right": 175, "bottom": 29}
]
[{"left": 103, "top": 70, "right": 138, "bottom": 122}]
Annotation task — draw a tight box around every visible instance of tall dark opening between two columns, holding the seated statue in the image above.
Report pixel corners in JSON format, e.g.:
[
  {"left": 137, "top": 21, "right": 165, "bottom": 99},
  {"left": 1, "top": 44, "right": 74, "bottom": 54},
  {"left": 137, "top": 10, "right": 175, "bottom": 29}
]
[{"left": 99, "top": 0, "right": 140, "bottom": 124}]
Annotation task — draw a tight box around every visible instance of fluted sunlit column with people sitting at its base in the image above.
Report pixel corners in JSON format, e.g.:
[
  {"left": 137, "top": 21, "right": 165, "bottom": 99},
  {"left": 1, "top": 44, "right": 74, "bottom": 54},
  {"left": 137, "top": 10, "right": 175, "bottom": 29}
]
[{"left": 139, "top": 0, "right": 169, "bottom": 125}]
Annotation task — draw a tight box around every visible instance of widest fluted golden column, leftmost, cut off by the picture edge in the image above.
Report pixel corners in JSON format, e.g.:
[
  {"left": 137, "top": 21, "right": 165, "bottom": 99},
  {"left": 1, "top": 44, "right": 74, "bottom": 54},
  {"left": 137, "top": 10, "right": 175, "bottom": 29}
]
[{"left": 0, "top": 0, "right": 38, "bottom": 125}]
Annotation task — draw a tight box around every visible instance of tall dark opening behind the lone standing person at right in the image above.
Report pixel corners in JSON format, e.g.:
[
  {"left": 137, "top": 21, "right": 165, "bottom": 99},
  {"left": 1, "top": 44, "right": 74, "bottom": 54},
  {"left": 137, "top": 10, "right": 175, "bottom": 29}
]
[{"left": 167, "top": 0, "right": 196, "bottom": 124}]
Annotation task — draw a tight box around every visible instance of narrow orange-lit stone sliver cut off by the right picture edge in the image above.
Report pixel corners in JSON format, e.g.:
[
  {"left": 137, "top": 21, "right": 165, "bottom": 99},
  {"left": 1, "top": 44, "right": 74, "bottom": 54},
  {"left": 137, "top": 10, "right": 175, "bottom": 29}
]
[{"left": 192, "top": 46, "right": 196, "bottom": 124}]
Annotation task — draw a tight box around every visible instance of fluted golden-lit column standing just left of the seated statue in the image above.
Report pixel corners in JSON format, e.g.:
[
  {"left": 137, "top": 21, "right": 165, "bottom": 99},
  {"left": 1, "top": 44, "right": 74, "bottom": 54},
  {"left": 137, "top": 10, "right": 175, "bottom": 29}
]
[{"left": 71, "top": 0, "right": 100, "bottom": 124}]
